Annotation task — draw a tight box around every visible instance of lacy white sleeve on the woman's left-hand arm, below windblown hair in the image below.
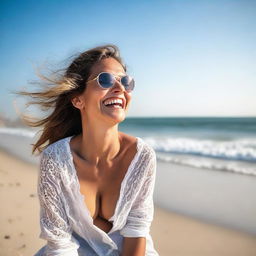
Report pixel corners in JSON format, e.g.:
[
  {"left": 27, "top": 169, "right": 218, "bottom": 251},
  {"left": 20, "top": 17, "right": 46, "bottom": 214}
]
[{"left": 38, "top": 151, "right": 79, "bottom": 256}]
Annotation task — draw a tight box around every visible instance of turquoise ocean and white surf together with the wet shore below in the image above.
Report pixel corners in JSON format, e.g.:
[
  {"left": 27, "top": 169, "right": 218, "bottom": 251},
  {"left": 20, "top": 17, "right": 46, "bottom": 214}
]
[{"left": 0, "top": 117, "right": 256, "bottom": 235}]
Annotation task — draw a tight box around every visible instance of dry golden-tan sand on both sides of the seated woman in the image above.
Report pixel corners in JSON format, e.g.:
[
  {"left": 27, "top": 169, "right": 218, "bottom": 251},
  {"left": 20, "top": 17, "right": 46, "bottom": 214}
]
[{"left": 0, "top": 151, "right": 256, "bottom": 256}]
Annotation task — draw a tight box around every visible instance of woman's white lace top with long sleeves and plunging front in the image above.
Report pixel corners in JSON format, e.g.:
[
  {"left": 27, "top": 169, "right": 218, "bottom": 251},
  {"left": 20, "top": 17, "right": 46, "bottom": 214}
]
[{"left": 35, "top": 136, "right": 158, "bottom": 256}]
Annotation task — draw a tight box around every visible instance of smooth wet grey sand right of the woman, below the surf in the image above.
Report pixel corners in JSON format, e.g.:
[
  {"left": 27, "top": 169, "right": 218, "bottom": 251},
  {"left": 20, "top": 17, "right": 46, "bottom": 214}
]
[{"left": 154, "top": 161, "right": 256, "bottom": 236}]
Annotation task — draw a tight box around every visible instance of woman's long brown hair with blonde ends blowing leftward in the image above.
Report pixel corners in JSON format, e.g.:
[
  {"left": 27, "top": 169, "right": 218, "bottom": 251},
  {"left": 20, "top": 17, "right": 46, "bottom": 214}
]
[{"left": 15, "top": 44, "right": 126, "bottom": 154}]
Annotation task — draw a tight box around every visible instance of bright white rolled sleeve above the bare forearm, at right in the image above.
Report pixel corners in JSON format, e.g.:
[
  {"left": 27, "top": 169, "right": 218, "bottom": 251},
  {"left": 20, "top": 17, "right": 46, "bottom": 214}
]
[{"left": 120, "top": 149, "right": 156, "bottom": 237}]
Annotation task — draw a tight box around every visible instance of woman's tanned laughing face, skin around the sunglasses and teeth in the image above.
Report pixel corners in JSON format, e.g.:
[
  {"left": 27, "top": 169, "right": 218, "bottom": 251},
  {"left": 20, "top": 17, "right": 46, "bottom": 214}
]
[{"left": 75, "top": 58, "right": 131, "bottom": 125}]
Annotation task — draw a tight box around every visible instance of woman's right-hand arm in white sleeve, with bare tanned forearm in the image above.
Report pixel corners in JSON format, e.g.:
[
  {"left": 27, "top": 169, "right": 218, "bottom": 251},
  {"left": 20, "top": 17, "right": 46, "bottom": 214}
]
[{"left": 120, "top": 146, "right": 156, "bottom": 256}]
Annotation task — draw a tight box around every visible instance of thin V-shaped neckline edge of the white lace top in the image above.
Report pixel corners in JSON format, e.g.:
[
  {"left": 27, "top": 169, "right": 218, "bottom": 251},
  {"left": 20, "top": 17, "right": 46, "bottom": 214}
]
[{"left": 66, "top": 135, "right": 142, "bottom": 234}]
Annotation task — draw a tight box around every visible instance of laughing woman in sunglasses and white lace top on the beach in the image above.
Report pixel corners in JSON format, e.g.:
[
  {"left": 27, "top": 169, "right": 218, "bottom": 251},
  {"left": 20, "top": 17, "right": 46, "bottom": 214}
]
[{"left": 17, "top": 45, "right": 158, "bottom": 256}]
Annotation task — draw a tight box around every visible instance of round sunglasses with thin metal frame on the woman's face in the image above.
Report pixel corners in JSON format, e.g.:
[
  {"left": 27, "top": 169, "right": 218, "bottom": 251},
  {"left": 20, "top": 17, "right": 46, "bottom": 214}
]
[{"left": 87, "top": 72, "right": 135, "bottom": 92}]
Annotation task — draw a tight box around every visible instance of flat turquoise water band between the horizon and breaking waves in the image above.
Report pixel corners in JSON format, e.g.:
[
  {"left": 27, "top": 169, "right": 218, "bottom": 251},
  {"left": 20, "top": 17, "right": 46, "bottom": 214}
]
[{"left": 119, "top": 117, "right": 256, "bottom": 140}]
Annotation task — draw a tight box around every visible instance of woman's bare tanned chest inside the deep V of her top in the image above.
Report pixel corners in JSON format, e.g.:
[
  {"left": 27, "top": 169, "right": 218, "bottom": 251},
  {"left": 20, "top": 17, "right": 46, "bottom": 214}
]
[{"left": 75, "top": 143, "right": 136, "bottom": 232}]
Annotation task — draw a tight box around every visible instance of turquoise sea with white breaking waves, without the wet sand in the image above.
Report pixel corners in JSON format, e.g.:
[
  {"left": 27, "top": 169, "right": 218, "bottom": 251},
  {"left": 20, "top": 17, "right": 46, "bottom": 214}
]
[{"left": 0, "top": 117, "right": 256, "bottom": 176}]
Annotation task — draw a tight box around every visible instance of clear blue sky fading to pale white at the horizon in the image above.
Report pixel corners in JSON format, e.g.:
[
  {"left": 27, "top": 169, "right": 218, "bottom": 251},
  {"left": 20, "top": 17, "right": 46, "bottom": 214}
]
[{"left": 0, "top": 0, "right": 256, "bottom": 118}]
